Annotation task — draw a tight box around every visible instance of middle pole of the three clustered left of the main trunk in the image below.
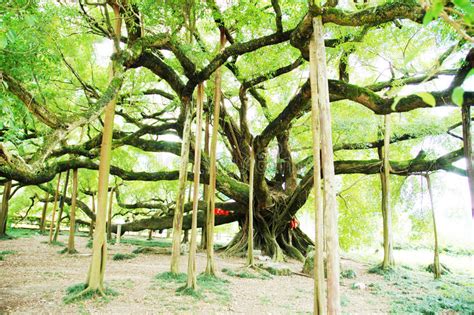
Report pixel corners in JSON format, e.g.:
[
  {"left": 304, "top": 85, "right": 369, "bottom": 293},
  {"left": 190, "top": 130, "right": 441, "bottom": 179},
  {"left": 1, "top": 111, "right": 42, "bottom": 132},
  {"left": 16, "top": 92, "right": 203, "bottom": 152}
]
[{"left": 186, "top": 83, "right": 204, "bottom": 289}]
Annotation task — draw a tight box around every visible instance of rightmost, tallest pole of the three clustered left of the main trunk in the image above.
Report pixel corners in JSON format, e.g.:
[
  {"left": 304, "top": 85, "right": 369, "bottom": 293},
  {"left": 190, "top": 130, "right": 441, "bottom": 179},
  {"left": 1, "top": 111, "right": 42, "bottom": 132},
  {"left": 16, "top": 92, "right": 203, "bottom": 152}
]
[{"left": 206, "top": 28, "right": 226, "bottom": 275}]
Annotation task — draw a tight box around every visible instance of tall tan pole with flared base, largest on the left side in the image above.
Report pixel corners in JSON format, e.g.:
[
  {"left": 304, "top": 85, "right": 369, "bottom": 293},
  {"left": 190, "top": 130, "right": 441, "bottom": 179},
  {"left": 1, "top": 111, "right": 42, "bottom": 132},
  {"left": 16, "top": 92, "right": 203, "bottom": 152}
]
[{"left": 86, "top": 3, "right": 122, "bottom": 294}]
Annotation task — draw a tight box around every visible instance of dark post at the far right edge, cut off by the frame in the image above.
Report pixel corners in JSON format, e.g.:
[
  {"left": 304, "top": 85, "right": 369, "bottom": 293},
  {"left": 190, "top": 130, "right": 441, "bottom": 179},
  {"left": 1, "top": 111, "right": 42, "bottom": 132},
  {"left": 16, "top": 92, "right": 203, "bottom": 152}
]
[{"left": 461, "top": 102, "right": 474, "bottom": 220}]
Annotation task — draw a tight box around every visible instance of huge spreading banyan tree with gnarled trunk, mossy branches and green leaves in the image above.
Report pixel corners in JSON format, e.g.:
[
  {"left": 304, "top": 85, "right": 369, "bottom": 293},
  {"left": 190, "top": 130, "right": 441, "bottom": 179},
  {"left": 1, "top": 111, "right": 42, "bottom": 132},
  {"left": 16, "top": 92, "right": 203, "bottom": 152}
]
[{"left": 0, "top": 0, "right": 474, "bottom": 274}]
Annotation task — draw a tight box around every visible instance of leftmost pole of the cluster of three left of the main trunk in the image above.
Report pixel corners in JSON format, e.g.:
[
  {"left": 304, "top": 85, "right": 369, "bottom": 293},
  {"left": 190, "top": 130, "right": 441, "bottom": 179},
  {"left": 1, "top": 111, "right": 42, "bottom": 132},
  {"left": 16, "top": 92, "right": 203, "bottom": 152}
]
[{"left": 171, "top": 99, "right": 192, "bottom": 274}]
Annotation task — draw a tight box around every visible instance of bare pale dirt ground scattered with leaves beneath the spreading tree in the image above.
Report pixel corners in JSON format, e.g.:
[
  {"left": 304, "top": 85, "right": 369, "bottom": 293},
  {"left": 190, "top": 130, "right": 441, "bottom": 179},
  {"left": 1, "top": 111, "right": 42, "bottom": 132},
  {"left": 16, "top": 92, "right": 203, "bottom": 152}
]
[{"left": 0, "top": 235, "right": 472, "bottom": 314}]
